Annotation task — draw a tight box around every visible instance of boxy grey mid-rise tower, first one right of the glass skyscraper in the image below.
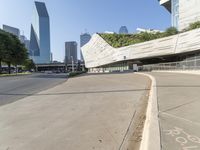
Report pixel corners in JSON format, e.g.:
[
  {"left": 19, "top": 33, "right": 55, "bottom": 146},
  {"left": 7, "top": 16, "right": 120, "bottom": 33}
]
[{"left": 65, "top": 41, "right": 78, "bottom": 64}]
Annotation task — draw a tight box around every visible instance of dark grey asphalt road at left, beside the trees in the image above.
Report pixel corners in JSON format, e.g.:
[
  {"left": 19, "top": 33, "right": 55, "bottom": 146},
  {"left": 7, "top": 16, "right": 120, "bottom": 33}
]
[{"left": 0, "top": 74, "right": 67, "bottom": 106}]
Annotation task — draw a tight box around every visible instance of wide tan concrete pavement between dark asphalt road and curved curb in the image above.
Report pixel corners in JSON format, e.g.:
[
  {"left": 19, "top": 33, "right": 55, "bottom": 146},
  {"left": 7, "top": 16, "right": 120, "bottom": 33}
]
[{"left": 0, "top": 73, "right": 150, "bottom": 150}]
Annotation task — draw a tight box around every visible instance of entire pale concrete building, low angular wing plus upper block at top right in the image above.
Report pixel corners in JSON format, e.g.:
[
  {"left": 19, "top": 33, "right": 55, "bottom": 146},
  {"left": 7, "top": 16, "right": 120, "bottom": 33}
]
[{"left": 82, "top": 0, "right": 200, "bottom": 72}]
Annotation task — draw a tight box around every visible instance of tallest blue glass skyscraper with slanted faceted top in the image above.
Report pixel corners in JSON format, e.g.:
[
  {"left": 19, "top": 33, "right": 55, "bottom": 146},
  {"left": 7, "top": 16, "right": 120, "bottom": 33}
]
[{"left": 29, "top": 2, "right": 51, "bottom": 64}]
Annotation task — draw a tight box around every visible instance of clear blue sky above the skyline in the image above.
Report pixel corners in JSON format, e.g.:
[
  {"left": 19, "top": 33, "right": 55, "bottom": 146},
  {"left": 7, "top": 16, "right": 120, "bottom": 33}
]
[{"left": 0, "top": 0, "right": 171, "bottom": 61}]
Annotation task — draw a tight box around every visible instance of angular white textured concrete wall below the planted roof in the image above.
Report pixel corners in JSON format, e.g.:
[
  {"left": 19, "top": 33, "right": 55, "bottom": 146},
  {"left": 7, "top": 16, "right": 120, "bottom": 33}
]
[{"left": 82, "top": 29, "right": 200, "bottom": 68}]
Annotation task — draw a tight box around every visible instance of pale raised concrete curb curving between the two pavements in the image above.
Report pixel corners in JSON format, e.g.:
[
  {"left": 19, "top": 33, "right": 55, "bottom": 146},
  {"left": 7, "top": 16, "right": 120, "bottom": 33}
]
[{"left": 137, "top": 73, "right": 161, "bottom": 150}]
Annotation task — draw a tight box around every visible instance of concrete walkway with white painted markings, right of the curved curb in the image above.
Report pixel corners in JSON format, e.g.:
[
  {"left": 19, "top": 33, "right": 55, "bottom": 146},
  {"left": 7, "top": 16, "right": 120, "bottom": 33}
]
[{"left": 150, "top": 72, "right": 200, "bottom": 150}]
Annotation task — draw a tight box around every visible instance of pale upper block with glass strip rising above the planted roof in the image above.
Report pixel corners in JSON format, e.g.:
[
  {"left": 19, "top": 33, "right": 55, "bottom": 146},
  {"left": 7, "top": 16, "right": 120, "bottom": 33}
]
[{"left": 159, "top": 0, "right": 200, "bottom": 31}]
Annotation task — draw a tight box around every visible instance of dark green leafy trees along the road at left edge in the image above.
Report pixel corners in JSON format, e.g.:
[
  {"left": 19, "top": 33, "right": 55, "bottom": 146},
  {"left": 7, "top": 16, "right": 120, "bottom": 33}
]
[{"left": 0, "top": 29, "right": 33, "bottom": 74}]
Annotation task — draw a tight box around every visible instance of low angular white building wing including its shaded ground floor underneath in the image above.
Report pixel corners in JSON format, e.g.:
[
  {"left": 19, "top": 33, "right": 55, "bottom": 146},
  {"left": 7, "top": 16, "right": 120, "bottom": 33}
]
[{"left": 82, "top": 29, "right": 200, "bottom": 72}]
